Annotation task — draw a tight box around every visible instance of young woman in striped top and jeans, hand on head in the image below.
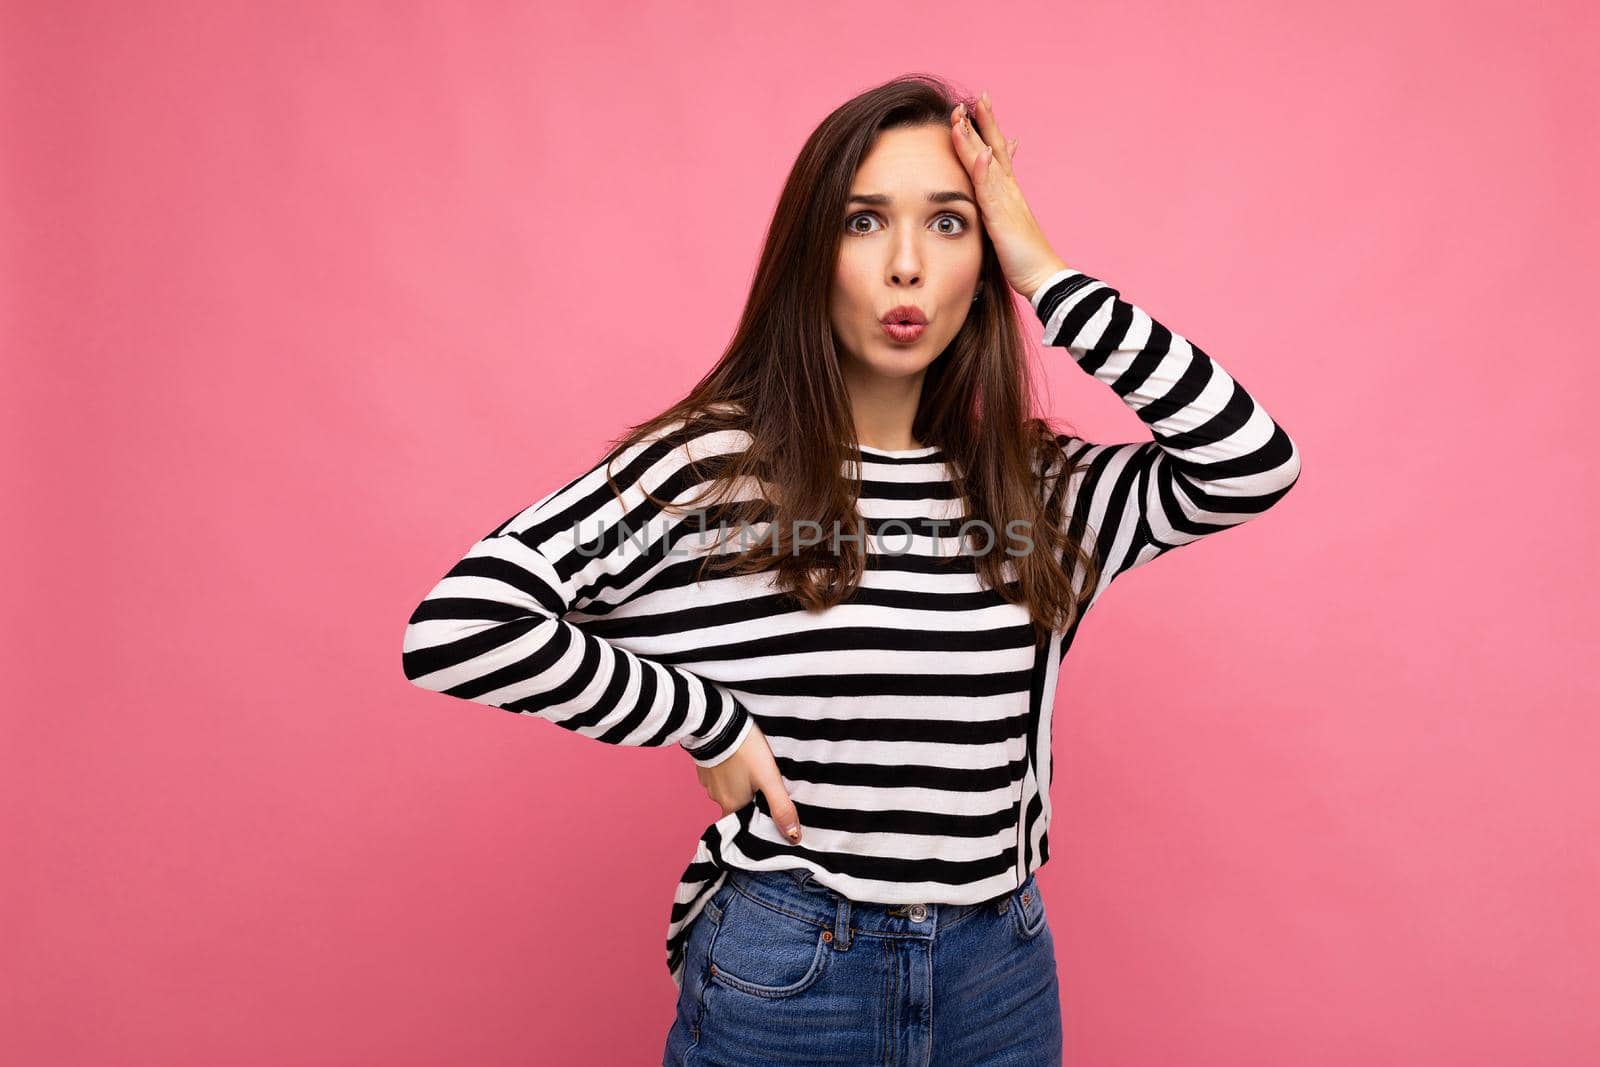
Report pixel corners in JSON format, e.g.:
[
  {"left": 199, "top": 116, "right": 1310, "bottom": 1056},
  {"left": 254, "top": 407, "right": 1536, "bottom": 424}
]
[{"left": 405, "top": 75, "right": 1299, "bottom": 1064}]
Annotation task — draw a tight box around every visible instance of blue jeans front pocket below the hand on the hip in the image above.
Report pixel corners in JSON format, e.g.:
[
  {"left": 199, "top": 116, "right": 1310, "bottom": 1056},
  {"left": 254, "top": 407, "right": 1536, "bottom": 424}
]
[{"left": 709, "top": 891, "right": 832, "bottom": 998}]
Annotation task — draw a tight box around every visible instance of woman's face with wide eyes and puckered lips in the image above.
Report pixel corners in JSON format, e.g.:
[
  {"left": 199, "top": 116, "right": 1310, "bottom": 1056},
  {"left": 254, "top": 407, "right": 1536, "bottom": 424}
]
[{"left": 829, "top": 125, "right": 982, "bottom": 378}]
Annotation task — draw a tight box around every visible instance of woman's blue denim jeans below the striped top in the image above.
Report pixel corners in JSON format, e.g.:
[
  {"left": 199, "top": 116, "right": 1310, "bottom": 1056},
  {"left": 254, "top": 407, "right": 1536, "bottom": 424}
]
[{"left": 662, "top": 869, "right": 1061, "bottom": 1067}]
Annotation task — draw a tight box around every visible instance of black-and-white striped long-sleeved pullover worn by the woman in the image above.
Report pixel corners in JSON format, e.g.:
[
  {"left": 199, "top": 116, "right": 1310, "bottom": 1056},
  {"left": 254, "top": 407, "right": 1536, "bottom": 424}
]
[{"left": 403, "top": 269, "right": 1299, "bottom": 989}]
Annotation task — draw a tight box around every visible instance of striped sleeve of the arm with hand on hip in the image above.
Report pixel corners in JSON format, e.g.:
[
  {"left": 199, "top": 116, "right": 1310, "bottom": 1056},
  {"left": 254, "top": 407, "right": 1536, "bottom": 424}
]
[{"left": 402, "top": 428, "right": 754, "bottom": 766}]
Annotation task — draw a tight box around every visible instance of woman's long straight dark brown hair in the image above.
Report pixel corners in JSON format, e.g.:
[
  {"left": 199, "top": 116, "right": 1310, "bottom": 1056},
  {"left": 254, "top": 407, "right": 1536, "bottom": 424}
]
[{"left": 606, "top": 74, "right": 1098, "bottom": 641}]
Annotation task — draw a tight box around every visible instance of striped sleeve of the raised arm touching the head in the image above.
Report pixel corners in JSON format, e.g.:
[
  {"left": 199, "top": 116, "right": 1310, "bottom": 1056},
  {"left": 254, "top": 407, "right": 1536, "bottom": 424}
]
[{"left": 1032, "top": 267, "right": 1301, "bottom": 595}]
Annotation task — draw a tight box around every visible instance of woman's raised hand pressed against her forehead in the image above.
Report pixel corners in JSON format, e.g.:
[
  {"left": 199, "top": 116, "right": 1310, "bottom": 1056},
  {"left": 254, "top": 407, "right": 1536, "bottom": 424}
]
[{"left": 950, "top": 91, "right": 1067, "bottom": 299}]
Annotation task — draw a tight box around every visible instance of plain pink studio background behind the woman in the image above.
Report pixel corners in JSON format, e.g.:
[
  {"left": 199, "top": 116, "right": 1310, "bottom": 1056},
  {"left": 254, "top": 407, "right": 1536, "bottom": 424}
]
[{"left": 0, "top": 2, "right": 1600, "bottom": 1067}]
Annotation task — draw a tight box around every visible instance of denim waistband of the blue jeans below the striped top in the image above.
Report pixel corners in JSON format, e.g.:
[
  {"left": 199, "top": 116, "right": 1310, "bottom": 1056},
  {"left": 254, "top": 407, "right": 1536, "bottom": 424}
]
[{"left": 728, "top": 867, "right": 1034, "bottom": 949}]
